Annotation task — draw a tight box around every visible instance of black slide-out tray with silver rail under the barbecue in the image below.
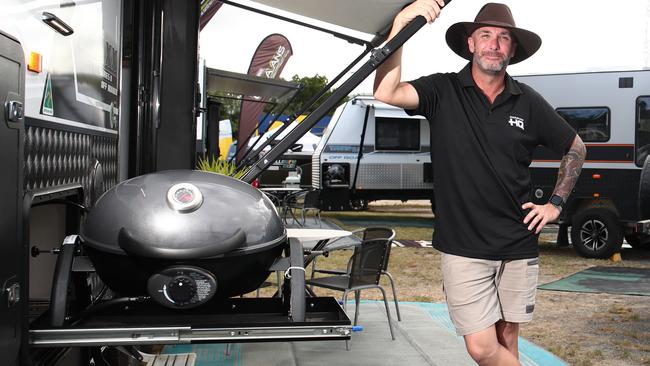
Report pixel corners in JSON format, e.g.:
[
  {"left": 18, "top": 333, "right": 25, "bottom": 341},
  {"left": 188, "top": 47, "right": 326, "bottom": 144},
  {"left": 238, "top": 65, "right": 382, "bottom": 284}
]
[{"left": 29, "top": 297, "right": 352, "bottom": 347}]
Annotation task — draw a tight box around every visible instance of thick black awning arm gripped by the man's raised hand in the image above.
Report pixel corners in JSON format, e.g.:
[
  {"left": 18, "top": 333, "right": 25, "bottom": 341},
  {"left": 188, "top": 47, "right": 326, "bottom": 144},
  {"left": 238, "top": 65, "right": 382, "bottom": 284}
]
[{"left": 241, "top": 12, "right": 442, "bottom": 183}]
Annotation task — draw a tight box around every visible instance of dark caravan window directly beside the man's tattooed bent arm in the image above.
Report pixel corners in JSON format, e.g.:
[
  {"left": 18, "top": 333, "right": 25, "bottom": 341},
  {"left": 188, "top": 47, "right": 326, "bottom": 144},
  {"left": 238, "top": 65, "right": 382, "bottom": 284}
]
[{"left": 556, "top": 107, "right": 611, "bottom": 142}]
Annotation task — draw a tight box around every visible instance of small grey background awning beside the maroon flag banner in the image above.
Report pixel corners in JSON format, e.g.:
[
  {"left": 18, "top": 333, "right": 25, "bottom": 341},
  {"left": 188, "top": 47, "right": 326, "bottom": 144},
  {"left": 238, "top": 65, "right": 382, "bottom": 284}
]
[{"left": 206, "top": 68, "right": 300, "bottom": 103}]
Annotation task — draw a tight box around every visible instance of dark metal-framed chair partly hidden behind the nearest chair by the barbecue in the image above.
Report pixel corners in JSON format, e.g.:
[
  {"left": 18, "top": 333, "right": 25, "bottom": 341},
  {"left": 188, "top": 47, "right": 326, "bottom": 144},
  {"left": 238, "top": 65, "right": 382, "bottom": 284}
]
[{"left": 311, "top": 227, "right": 402, "bottom": 321}]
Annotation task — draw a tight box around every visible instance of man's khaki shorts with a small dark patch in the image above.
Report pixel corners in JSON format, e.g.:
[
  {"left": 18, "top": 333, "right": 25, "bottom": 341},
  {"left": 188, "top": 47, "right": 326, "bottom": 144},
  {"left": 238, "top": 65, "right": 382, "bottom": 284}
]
[{"left": 441, "top": 253, "right": 539, "bottom": 335}]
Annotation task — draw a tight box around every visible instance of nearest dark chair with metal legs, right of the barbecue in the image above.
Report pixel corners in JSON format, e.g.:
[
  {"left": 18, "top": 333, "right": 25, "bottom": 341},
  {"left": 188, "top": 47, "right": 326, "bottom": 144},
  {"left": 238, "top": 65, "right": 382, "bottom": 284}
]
[{"left": 305, "top": 239, "right": 395, "bottom": 340}]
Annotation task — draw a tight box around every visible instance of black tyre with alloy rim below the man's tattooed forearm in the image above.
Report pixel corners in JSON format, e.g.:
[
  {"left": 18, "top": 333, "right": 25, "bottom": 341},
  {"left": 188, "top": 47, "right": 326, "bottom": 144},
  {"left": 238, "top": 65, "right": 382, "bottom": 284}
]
[{"left": 571, "top": 208, "right": 623, "bottom": 258}]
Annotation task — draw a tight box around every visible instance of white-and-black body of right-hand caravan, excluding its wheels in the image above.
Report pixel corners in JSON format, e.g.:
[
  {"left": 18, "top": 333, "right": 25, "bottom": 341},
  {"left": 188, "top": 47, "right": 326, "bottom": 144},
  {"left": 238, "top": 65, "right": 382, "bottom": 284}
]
[{"left": 516, "top": 71, "right": 650, "bottom": 222}]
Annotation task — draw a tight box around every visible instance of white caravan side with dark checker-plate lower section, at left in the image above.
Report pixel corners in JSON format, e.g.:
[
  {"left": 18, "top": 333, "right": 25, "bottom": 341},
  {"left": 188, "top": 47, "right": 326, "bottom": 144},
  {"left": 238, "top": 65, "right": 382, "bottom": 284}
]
[{"left": 0, "top": 0, "right": 122, "bottom": 204}]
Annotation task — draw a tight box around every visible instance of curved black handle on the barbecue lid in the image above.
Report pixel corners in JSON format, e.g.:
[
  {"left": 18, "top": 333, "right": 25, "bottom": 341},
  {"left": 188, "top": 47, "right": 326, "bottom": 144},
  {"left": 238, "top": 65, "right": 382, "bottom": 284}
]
[{"left": 117, "top": 228, "right": 246, "bottom": 260}]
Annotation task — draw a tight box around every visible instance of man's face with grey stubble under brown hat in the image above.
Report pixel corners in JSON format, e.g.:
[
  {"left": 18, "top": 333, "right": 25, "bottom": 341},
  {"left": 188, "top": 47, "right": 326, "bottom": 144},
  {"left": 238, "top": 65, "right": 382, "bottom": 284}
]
[{"left": 467, "top": 27, "right": 517, "bottom": 75}]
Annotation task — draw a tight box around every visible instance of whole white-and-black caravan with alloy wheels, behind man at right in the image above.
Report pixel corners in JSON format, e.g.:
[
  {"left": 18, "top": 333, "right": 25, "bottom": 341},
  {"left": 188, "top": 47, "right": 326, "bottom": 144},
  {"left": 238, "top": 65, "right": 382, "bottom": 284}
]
[{"left": 516, "top": 70, "right": 650, "bottom": 258}]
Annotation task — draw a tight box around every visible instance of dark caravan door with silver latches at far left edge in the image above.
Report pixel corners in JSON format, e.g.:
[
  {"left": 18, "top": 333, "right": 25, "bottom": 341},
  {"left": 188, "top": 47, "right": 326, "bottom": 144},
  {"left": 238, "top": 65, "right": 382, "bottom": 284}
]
[{"left": 0, "top": 32, "right": 26, "bottom": 366}]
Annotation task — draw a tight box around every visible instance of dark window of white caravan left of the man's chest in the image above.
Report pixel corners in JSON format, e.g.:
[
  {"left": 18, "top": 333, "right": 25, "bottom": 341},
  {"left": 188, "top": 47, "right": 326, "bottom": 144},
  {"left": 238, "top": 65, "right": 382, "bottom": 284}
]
[{"left": 375, "top": 117, "right": 420, "bottom": 151}]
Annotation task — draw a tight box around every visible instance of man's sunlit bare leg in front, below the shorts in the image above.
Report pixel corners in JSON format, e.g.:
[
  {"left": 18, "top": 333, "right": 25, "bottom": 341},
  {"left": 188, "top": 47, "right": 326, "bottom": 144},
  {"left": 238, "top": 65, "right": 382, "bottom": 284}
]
[{"left": 465, "top": 325, "right": 521, "bottom": 366}]
